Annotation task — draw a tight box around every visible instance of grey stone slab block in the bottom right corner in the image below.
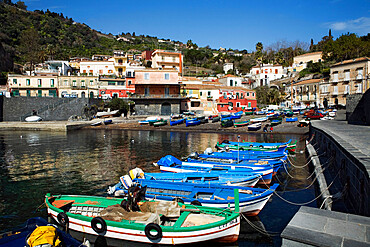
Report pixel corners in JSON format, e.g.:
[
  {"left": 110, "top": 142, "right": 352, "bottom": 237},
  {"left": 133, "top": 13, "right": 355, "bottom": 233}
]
[{"left": 281, "top": 207, "right": 370, "bottom": 247}]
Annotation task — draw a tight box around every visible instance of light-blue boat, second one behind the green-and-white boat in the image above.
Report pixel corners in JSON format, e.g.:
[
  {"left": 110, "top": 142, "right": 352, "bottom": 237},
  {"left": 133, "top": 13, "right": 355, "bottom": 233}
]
[{"left": 145, "top": 172, "right": 261, "bottom": 187}]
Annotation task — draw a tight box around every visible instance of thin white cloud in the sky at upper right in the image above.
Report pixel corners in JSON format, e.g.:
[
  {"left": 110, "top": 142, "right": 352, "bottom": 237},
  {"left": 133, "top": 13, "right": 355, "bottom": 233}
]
[{"left": 325, "top": 17, "right": 370, "bottom": 33}]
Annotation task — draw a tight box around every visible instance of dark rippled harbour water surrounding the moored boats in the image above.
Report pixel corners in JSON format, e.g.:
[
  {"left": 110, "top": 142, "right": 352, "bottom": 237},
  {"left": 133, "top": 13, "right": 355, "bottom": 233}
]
[{"left": 0, "top": 130, "right": 317, "bottom": 246}]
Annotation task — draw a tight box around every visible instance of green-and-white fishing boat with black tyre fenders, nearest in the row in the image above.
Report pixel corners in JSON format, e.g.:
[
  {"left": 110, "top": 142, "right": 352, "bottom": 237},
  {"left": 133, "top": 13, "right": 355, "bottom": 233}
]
[{"left": 45, "top": 195, "right": 240, "bottom": 246}]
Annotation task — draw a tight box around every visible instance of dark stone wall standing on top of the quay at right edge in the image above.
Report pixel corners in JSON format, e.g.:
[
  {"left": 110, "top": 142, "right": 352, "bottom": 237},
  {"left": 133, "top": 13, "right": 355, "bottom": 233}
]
[{"left": 346, "top": 89, "right": 370, "bottom": 125}]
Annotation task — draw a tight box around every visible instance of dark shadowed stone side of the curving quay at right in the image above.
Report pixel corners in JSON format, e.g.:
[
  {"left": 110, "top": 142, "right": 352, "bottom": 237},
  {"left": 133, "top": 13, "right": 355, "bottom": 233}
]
[{"left": 310, "top": 126, "right": 370, "bottom": 216}]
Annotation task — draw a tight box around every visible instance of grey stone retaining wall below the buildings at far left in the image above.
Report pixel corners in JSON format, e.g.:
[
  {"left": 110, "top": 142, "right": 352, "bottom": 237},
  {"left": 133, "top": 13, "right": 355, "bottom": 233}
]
[{"left": 2, "top": 97, "right": 100, "bottom": 121}]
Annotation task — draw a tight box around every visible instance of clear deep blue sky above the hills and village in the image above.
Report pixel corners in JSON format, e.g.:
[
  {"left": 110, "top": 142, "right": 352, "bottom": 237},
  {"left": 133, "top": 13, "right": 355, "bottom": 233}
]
[{"left": 23, "top": 0, "right": 370, "bottom": 52}]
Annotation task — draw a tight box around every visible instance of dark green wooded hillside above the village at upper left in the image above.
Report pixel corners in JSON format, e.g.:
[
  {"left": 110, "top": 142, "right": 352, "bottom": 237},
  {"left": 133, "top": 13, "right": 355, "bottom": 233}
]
[{"left": 0, "top": 2, "right": 179, "bottom": 64}]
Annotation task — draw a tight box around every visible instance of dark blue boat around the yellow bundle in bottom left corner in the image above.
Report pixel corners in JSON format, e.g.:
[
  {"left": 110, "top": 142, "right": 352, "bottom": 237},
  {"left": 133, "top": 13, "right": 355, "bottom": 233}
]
[{"left": 0, "top": 217, "right": 82, "bottom": 247}]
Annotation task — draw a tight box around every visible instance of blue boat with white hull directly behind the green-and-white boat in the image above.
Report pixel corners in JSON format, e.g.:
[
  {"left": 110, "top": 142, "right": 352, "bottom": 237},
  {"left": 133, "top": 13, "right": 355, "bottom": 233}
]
[{"left": 114, "top": 179, "right": 278, "bottom": 216}]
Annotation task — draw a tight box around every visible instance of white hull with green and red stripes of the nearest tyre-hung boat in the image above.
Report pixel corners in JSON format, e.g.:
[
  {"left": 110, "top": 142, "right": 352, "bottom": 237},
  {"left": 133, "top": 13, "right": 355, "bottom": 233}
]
[{"left": 46, "top": 195, "right": 240, "bottom": 246}]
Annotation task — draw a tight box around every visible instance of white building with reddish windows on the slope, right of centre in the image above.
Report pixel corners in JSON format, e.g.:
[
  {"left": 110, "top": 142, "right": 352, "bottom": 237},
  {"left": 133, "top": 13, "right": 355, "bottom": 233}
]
[{"left": 251, "top": 64, "right": 285, "bottom": 88}]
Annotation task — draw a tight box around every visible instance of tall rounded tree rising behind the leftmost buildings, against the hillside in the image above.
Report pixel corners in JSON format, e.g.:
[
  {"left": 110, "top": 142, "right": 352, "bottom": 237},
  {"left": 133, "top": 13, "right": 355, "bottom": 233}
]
[{"left": 19, "top": 27, "right": 41, "bottom": 71}]
